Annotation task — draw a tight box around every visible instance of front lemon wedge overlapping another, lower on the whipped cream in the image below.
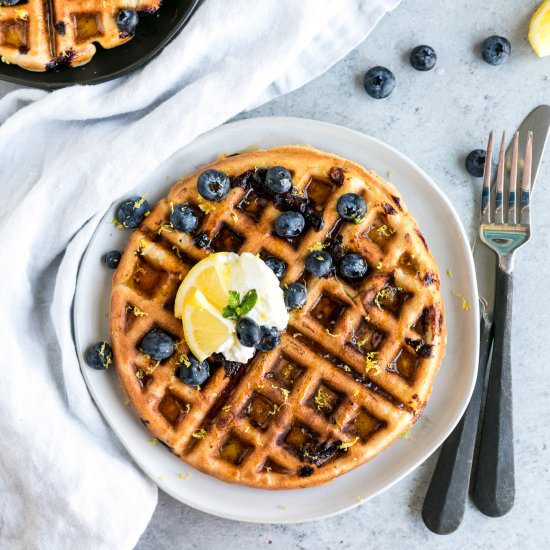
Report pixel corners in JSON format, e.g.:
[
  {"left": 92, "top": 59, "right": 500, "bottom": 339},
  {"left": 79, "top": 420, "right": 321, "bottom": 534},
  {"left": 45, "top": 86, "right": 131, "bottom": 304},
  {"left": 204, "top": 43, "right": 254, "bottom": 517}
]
[{"left": 182, "top": 288, "right": 233, "bottom": 361}]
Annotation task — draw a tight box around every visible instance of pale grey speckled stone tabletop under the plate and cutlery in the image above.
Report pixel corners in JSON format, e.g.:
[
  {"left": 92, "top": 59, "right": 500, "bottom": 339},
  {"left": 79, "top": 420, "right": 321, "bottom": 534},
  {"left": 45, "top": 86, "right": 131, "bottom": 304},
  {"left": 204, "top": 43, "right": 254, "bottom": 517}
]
[{"left": 0, "top": 0, "right": 550, "bottom": 550}]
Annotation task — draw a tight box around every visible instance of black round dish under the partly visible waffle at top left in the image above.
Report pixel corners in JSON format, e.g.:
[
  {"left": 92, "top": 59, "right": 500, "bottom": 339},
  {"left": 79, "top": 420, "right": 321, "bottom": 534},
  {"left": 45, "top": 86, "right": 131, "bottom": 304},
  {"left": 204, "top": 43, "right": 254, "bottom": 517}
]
[{"left": 0, "top": 0, "right": 200, "bottom": 90}]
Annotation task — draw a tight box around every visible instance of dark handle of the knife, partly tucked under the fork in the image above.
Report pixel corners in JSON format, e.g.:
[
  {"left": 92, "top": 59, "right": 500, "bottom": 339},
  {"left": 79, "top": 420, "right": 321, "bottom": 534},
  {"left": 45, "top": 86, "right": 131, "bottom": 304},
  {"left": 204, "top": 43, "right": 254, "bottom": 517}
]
[{"left": 422, "top": 315, "right": 492, "bottom": 535}]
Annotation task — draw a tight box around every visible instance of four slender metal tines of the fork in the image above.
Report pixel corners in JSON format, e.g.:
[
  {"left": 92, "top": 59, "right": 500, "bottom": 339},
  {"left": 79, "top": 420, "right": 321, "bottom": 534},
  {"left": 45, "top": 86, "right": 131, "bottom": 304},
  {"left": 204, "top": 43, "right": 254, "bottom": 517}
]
[{"left": 481, "top": 131, "right": 533, "bottom": 225}]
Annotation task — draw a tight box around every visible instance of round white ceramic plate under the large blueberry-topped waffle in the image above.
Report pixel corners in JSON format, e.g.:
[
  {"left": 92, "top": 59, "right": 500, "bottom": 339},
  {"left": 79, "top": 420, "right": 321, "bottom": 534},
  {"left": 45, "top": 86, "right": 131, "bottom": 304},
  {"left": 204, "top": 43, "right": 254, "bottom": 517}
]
[{"left": 74, "top": 118, "right": 479, "bottom": 523}]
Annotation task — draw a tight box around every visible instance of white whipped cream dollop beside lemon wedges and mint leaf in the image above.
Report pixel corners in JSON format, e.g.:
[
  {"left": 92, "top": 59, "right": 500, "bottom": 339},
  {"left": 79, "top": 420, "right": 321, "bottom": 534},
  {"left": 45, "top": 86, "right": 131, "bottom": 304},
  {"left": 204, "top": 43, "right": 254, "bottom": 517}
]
[{"left": 216, "top": 252, "right": 289, "bottom": 363}]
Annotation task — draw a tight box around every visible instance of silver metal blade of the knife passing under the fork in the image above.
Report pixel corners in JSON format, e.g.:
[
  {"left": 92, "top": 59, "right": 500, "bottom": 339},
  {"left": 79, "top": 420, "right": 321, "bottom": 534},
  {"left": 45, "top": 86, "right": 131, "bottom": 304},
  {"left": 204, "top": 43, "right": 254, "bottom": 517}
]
[{"left": 472, "top": 105, "right": 550, "bottom": 324}]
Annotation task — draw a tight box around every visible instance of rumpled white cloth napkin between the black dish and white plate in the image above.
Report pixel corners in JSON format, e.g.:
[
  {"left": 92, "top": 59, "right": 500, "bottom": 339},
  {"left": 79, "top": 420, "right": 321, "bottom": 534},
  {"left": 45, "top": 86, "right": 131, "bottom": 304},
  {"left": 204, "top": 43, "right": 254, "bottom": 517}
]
[{"left": 0, "top": 0, "right": 399, "bottom": 550}]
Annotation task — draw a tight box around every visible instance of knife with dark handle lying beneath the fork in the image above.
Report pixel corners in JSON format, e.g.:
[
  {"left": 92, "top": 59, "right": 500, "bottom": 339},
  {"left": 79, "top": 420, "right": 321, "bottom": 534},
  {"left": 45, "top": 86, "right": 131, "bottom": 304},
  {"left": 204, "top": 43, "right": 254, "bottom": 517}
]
[{"left": 422, "top": 105, "right": 550, "bottom": 534}]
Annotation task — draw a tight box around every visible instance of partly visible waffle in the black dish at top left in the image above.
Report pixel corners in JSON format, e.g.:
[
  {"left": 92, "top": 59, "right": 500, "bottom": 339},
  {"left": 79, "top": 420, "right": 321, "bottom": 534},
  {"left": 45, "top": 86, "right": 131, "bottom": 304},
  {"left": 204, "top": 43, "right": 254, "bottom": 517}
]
[{"left": 0, "top": 0, "right": 160, "bottom": 71}]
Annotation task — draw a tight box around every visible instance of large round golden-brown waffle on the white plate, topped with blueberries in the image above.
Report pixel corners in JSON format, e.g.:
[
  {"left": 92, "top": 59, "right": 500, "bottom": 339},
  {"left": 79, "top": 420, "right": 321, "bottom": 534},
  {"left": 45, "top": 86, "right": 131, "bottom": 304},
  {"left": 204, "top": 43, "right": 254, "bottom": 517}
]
[{"left": 111, "top": 146, "right": 446, "bottom": 489}]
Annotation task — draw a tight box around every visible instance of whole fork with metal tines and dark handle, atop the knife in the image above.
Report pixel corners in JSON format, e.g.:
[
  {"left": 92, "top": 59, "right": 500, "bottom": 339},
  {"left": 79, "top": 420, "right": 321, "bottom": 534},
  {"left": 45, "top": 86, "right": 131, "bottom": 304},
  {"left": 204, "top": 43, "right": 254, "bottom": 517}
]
[{"left": 472, "top": 132, "right": 533, "bottom": 517}]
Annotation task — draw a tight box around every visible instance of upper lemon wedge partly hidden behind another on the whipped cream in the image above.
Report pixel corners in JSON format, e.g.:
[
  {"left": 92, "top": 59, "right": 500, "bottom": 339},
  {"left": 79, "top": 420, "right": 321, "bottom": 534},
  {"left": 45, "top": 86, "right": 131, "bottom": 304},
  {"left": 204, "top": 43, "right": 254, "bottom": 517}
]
[{"left": 174, "top": 252, "right": 229, "bottom": 319}]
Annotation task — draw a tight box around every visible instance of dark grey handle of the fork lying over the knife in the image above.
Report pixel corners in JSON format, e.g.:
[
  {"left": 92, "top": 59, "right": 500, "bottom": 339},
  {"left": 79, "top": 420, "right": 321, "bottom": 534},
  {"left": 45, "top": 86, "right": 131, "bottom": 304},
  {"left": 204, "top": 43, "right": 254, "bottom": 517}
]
[{"left": 472, "top": 267, "right": 515, "bottom": 517}]
